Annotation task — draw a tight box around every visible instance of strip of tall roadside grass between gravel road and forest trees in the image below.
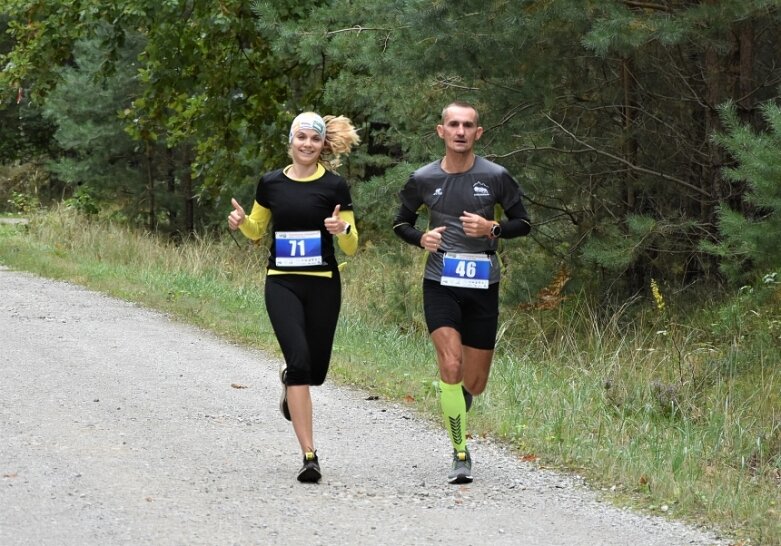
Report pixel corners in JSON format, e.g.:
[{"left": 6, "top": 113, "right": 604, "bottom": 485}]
[{"left": 0, "top": 209, "right": 781, "bottom": 544}]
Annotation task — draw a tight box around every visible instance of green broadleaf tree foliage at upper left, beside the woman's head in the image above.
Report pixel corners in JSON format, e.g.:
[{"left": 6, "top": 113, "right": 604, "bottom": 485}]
[{"left": 0, "top": 0, "right": 338, "bottom": 227}]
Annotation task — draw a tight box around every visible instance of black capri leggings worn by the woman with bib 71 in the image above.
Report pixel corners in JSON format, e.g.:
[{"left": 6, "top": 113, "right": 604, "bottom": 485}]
[{"left": 265, "top": 271, "right": 342, "bottom": 385}]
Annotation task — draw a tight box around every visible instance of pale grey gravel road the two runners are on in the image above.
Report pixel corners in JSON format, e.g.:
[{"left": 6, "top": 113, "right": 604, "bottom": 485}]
[{"left": 0, "top": 267, "right": 727, "bottom": 546}]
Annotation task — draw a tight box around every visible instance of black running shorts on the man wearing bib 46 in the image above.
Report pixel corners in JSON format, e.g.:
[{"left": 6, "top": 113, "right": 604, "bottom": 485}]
[{"left": 423, "top": 279, "right": 499, "bottom": 350}]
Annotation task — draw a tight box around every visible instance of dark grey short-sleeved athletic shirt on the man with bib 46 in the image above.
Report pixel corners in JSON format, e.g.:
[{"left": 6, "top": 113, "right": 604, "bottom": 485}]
[{"left": 399, "top": 156, "right": 522, "bottom": 283}]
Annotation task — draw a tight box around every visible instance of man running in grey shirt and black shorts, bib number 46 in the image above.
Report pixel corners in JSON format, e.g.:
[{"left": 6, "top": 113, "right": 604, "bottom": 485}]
[{"left": 393, "top": 102, "right": 531, "bottom": 483}]
